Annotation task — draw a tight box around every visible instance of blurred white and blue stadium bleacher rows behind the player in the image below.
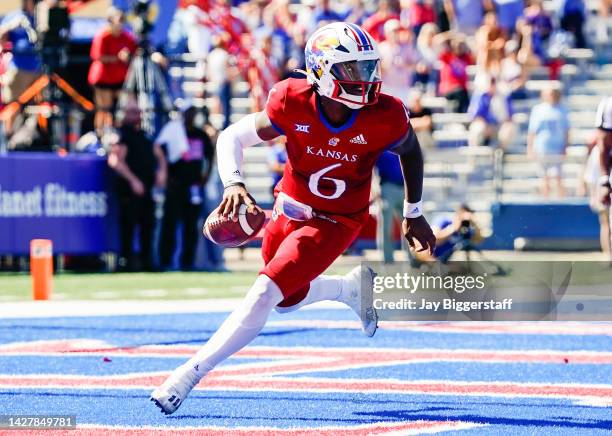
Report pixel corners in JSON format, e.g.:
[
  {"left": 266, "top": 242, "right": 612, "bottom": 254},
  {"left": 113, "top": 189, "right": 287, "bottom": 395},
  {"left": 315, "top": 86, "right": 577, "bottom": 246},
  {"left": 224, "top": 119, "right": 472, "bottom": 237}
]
[{"left": 2, "top": 0, "right": 612, "bottom": 255}]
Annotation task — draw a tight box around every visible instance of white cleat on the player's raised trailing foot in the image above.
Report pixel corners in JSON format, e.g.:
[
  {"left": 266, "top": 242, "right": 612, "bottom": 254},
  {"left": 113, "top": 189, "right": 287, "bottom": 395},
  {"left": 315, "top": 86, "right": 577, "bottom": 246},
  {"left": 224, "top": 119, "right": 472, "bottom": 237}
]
[{"left": 340, "top": 266, "right": 378, "bottom": 337}]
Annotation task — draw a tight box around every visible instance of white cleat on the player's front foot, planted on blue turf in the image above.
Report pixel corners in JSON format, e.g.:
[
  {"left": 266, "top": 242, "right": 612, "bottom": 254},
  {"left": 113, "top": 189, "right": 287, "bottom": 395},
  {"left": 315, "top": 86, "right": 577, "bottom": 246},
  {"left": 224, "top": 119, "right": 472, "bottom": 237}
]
[{"left": 151, "top": 365, "right": 201, "bottom": 415}]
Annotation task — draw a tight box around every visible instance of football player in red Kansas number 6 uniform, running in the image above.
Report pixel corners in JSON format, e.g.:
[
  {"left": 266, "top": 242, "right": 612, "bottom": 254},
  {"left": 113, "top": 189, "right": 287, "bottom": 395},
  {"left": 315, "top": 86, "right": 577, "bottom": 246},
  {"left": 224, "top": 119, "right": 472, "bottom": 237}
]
[{"left": 151, "top": 23, "right": 435, "bottom": 414}]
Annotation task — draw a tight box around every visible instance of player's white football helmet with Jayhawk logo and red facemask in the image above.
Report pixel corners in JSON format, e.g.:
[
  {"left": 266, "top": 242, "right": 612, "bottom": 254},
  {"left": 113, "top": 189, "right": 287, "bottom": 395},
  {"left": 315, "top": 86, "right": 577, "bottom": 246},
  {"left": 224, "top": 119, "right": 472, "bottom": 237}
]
[{"left": 305, "top": 22, "right": 382, "bottom": 109}]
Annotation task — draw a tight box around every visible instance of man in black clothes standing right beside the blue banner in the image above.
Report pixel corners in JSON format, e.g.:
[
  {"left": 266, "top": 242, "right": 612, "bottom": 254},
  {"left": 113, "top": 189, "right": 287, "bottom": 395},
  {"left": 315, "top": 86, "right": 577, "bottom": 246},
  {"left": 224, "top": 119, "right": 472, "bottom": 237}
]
[{"left": 108, "top": 102, "right": 167, "bottom": 271}]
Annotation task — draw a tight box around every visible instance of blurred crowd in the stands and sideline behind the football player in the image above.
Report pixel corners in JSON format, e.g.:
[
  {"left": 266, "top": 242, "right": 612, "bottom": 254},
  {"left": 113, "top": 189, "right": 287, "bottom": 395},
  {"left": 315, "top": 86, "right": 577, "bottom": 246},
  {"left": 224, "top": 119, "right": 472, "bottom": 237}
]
[{"left": 0, "top": 0, "right": 612, "bottom": 270}]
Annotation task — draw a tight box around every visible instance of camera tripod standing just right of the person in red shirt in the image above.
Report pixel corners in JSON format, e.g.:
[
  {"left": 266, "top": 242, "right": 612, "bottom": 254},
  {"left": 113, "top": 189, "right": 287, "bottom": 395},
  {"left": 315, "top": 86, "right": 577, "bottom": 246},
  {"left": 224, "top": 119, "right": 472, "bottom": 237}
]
[{"left": 118, "top": 44, "right": 173, "bottom": 135}]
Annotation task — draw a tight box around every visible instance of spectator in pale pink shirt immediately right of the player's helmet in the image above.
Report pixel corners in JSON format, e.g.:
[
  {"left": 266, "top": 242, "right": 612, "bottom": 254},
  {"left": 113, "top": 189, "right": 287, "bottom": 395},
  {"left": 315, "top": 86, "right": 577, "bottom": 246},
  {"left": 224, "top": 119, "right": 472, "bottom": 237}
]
[{"left": 378, "top": 19, "right": 419, "bottom": 101}]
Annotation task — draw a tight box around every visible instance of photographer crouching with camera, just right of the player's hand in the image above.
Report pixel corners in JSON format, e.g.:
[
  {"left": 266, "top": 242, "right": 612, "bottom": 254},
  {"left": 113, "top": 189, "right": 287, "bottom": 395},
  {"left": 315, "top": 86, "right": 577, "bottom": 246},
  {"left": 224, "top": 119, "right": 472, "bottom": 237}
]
[{"left": 413, "top": 203, "right": 482, "bottom": 263}]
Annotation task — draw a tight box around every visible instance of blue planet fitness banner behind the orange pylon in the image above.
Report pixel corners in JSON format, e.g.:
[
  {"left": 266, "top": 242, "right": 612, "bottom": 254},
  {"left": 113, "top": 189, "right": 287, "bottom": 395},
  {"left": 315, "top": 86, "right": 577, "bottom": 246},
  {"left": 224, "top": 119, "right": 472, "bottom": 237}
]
[{"left": 0, "top": 153, "right": 118, "bottom": 254}]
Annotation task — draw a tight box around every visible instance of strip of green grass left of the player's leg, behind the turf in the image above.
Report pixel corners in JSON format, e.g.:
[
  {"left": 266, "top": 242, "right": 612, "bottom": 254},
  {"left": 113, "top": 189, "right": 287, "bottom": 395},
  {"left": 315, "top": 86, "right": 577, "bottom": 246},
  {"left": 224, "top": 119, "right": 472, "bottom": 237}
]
[{"left": 0, "top": 272, "right": 257, "bottom": 301}]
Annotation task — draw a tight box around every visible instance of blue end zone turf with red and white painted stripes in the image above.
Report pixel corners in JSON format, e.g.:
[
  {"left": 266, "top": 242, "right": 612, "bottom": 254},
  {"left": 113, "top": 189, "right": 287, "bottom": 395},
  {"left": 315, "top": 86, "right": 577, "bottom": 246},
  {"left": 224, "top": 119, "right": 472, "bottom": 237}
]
[{"left": 0, "top": 310, "right": 612, "bottom": 435}]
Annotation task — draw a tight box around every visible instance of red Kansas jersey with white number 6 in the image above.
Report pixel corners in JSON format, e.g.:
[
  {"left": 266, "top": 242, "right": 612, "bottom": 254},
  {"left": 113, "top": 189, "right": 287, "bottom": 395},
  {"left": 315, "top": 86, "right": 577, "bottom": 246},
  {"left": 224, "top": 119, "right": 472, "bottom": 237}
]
[{"left": 266, "top": 79, "right": 410, "bottom": 215}]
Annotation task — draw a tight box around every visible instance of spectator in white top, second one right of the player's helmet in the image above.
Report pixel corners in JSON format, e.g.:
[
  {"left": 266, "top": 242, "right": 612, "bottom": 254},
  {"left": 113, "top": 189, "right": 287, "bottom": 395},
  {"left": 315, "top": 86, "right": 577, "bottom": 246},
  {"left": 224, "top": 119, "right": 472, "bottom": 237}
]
[{"left": 413, "top": 23, "right": 440, "bottom": 94}]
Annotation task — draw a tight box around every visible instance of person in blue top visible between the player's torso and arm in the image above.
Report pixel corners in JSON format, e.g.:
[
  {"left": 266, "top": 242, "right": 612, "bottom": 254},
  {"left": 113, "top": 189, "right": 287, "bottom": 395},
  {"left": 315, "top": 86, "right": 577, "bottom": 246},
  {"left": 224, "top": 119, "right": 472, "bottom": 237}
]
[{"left": 376, "top": 152, "right": 404, "bottom": 263}]
